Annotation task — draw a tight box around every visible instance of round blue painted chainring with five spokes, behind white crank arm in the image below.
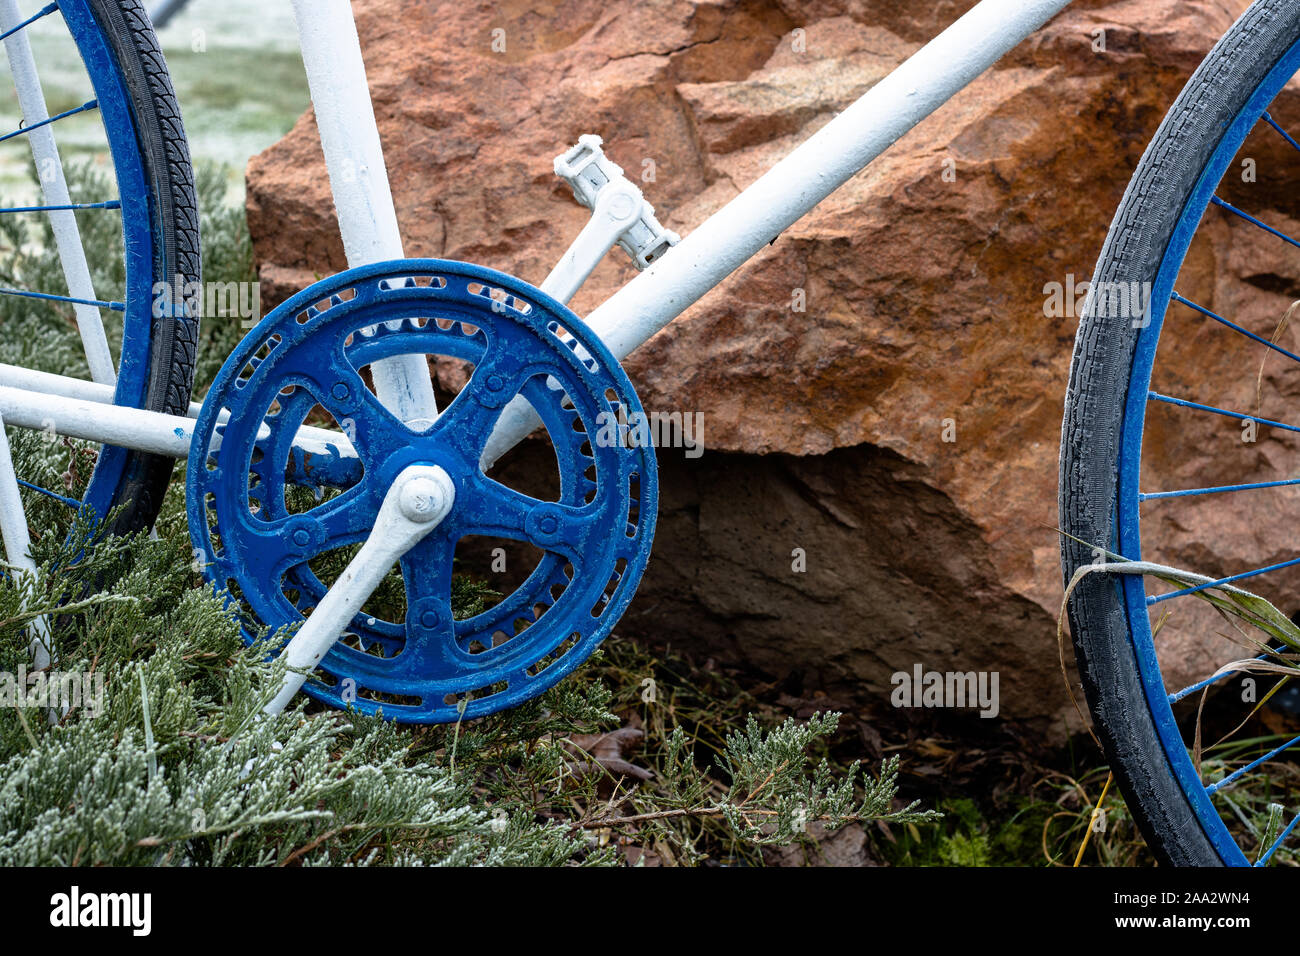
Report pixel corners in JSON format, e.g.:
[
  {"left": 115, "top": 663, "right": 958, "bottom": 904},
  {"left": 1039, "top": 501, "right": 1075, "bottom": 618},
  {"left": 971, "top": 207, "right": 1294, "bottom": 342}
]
[{"left": 187, "top": 259, "right": 658, "bottom": 723}]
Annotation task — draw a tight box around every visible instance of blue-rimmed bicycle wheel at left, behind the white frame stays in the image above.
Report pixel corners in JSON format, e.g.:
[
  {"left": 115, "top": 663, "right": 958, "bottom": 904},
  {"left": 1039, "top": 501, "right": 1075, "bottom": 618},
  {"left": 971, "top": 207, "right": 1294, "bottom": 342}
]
[{"left": 0, "top": 0, "right": 200, "bottom": 535}]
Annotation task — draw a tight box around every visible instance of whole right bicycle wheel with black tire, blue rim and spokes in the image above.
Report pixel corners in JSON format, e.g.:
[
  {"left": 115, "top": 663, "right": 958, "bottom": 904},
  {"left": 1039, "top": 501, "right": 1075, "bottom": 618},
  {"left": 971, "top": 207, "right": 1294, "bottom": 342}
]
[{"left": 1060, "top": 0, "right": 1300, "bottom": 865}]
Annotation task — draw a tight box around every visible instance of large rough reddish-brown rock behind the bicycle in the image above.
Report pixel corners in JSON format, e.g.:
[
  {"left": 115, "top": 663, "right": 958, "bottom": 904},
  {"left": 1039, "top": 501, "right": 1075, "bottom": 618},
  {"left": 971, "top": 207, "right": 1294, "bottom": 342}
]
[{"left": 248, "top": 0, "right": 1300, "bottom": 719}]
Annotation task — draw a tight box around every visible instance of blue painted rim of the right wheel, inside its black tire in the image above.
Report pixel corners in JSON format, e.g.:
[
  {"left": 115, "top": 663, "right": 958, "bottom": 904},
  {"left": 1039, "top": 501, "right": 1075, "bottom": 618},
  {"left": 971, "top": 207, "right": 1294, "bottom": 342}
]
[{"left": 1114, "top": 33, "right": 1300, "bottom": 866}]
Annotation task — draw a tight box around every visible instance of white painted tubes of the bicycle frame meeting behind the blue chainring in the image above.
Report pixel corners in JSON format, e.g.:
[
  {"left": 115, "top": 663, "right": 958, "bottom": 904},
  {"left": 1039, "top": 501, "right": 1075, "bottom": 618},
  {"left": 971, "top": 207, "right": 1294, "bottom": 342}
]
[{"left": 0, "top": 0, "right": 1070, "bottom": 522}]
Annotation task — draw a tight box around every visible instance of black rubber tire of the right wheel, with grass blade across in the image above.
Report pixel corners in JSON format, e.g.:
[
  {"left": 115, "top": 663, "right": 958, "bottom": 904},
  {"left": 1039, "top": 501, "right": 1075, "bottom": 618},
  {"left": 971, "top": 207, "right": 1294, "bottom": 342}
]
[{"left": 1058, "top": 0, "right": 1300, "bottom": 866}]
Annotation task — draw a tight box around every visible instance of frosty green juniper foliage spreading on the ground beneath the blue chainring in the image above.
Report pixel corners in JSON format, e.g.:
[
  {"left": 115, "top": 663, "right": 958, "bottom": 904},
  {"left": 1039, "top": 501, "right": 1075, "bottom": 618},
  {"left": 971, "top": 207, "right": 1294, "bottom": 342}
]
[{"left": 0, "top": 497, "right": 932, "bottom": 865}]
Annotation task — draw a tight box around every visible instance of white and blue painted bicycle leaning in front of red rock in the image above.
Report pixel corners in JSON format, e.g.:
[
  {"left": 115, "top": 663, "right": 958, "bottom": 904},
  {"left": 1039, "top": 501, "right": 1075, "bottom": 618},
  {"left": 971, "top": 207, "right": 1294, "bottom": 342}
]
[{"left": 0, "top": 0, "right": 1300, "bottom": 864}]
